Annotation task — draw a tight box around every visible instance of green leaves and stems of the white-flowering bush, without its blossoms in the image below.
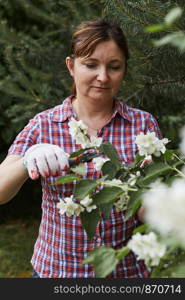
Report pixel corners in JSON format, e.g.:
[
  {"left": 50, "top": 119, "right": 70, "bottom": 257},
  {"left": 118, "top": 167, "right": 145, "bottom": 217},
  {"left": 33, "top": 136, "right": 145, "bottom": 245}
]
[{"left": 55, "top": 135, "right": 185, "bottom": 278}]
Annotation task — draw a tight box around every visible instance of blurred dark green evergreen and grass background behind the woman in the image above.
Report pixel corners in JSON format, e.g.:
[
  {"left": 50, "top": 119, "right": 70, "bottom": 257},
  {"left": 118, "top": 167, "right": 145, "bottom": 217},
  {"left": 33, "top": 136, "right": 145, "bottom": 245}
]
[{"left": 0, "top": 0, "right": 185, "bottom": 278}]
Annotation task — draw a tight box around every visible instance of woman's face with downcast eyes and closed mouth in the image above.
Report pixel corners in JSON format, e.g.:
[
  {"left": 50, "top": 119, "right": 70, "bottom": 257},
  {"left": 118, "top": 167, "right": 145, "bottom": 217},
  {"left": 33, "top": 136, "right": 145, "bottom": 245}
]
[{"left": 66, "top": 40, "right": 126, "bottom": 101}]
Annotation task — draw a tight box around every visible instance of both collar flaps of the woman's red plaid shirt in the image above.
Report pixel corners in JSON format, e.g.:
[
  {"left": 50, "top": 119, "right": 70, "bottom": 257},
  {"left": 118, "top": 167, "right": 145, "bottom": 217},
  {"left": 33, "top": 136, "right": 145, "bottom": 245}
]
[{"left": 52, "top": 95, "right": 131, "bottom": 122}]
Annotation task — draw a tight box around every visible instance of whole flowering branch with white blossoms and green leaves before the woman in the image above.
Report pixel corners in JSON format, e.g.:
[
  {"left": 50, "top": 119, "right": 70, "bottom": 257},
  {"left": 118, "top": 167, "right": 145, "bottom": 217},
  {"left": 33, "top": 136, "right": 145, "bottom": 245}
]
[{"left": 53, "top": 119, "right": 185, "bottom": 277}]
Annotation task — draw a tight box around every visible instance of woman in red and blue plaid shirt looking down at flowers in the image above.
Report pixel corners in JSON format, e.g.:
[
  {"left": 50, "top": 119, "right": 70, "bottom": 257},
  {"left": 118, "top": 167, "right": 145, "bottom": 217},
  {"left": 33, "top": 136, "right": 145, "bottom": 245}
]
[{"left": 0, "top": 19, "right": 160, "bottom": 278}]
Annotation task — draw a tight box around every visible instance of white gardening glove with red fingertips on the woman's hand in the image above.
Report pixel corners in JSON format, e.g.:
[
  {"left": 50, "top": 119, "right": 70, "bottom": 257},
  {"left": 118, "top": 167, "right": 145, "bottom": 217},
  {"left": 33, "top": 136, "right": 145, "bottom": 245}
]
[{"left": 23, "top": 143, "right": 69, "bottom": 179}]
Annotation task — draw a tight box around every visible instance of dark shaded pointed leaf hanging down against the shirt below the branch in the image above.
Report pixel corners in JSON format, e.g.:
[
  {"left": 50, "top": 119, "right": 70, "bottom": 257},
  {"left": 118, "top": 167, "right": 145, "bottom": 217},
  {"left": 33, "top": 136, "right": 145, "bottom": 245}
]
[{"left": 80, "top": 209, "right": 100, "bottom": 240}]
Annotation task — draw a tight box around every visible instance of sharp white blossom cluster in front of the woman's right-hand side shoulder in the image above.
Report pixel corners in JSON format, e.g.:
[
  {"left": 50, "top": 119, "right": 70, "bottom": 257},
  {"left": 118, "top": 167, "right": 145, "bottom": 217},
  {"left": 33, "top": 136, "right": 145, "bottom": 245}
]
[{"left": 135, "top": 132, "right": 169, "bottom": 156}]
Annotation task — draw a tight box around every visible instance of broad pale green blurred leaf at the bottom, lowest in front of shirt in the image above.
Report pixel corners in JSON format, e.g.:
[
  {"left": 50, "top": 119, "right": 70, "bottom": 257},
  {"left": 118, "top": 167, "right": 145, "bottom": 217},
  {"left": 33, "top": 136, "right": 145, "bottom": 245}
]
[{"left": 83, "top": 246, "right": 118, "bottom": 278}]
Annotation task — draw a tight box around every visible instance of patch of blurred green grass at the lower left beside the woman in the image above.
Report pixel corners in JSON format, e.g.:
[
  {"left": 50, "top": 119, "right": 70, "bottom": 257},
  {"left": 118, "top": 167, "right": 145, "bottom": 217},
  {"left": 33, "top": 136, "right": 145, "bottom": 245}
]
[{"left": 0, "top": 219, "right": 40, "bottom": 278}]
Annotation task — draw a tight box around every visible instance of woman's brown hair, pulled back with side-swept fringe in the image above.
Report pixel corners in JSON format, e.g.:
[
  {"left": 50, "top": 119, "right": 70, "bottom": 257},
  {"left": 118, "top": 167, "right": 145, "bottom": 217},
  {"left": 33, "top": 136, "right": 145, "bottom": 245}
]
[{"left": 70, "top": 18, "right": 129, "bottom": 94}]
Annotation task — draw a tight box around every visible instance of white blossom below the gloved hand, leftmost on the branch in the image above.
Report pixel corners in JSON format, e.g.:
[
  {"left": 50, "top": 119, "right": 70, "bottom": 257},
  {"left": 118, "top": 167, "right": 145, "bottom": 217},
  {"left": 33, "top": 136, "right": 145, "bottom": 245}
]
[{"left": 57, "top": 195, "right": 84, "bottom": 217}]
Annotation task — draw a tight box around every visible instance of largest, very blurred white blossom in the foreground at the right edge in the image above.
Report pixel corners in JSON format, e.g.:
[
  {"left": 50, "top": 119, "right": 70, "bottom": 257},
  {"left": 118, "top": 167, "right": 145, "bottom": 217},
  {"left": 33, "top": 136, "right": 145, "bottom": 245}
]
[{"left": 143, "top": 179, "right": 185, "bottom": 244}]
